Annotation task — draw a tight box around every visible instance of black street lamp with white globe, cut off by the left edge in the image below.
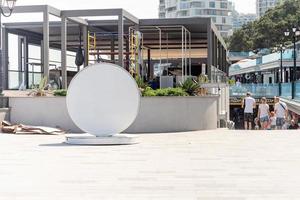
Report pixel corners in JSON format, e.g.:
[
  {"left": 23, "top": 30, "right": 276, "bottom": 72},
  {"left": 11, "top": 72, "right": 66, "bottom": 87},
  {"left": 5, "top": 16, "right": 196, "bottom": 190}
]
[{"left": 0, "top": 0, "right": 17, "bottom": 95}]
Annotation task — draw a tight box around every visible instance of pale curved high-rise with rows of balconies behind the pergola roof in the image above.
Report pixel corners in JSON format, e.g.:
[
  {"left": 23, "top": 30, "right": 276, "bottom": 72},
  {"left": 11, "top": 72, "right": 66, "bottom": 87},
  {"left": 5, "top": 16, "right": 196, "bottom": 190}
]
[{"left": 159, "top": 0, "right": 233, "bottom": 37}]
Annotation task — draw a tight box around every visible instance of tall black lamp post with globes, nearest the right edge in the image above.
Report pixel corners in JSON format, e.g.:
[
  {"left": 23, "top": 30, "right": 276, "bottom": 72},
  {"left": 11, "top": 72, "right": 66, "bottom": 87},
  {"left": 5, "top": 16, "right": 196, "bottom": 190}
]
[{"left": 284, "top": 27, "right": 300, "bottom": 99}]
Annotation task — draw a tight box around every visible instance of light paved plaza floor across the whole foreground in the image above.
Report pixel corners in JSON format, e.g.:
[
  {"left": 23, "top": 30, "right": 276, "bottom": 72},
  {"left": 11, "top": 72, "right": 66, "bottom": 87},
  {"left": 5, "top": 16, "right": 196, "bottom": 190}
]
[{"left": 0, "top": 130, "right": 300, "bottom": 200}]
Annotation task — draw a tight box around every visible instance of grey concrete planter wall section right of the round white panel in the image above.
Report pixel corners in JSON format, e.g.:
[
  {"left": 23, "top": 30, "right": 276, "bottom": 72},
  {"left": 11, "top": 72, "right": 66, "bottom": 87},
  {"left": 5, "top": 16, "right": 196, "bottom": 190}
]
[{"left": 125, "top": 96, "right": 219, "bottom": 133}]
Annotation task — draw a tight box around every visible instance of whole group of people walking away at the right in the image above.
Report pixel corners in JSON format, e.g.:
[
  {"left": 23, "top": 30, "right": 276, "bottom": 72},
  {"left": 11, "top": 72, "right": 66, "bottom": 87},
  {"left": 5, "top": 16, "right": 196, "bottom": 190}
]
[{"left": 242, "top": 92, "right": 299, "bottom": 130}]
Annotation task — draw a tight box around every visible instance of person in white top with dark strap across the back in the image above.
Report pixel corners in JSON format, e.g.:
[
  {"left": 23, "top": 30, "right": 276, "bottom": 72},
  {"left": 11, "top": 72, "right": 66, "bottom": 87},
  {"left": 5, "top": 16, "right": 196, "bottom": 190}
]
[{"left": 274, "top": 97, "right": 289, "bottom": 130}]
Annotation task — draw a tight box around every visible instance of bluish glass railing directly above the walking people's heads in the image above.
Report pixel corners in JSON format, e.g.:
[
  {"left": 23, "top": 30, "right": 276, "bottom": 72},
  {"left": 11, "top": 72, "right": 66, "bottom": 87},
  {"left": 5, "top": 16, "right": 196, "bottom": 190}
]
[{"left": 230, "top": 84, "right": 279, "bottom": 97}]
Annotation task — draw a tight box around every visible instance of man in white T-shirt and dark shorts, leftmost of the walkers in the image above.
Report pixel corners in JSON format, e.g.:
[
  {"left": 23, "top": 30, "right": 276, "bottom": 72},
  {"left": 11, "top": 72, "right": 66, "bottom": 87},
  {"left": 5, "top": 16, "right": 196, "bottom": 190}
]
[{"left": 242, "top": 92, "right": 256, "bottom": 130}]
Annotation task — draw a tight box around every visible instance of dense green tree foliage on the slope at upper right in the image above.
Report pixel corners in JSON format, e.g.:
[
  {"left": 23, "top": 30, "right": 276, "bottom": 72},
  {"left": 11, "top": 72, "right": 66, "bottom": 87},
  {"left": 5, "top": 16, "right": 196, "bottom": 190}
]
[{"left": 228, "top": 0, "right": 300, "bottom": 51}]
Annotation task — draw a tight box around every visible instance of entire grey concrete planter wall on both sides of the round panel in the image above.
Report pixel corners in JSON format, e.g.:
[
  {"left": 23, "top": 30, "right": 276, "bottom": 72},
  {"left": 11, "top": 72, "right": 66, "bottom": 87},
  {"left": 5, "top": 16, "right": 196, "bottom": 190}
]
[{"left": 9, "top": 96, "right": 219, "bottom": 133}]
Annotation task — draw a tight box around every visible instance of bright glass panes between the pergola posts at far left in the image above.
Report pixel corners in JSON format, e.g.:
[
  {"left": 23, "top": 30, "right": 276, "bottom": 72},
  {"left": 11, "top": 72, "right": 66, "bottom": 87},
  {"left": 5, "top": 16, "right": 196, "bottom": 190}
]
[{"left": 8, "top": 34, "right": 77, "bottom": 90}]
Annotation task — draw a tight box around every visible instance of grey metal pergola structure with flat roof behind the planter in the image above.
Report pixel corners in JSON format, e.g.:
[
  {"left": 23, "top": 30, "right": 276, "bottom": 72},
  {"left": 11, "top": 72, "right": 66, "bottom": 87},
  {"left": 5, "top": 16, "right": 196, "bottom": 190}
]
[{"left": 2, "top": 5, "right": 228, "bottom": 89}]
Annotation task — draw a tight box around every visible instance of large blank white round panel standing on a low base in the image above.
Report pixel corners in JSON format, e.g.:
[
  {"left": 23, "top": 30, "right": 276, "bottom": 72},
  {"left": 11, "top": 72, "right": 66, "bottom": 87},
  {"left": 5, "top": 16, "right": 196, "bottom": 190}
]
[{"left": 67, "top": 63, "right": 140, "bottom": 137}]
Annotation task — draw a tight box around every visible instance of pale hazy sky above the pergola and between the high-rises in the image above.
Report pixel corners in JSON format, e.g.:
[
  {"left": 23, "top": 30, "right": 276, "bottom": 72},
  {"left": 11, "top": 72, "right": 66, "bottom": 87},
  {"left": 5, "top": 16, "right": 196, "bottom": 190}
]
[{"left": 13, "top": 0, "right": 255, "bottom": 18}]
